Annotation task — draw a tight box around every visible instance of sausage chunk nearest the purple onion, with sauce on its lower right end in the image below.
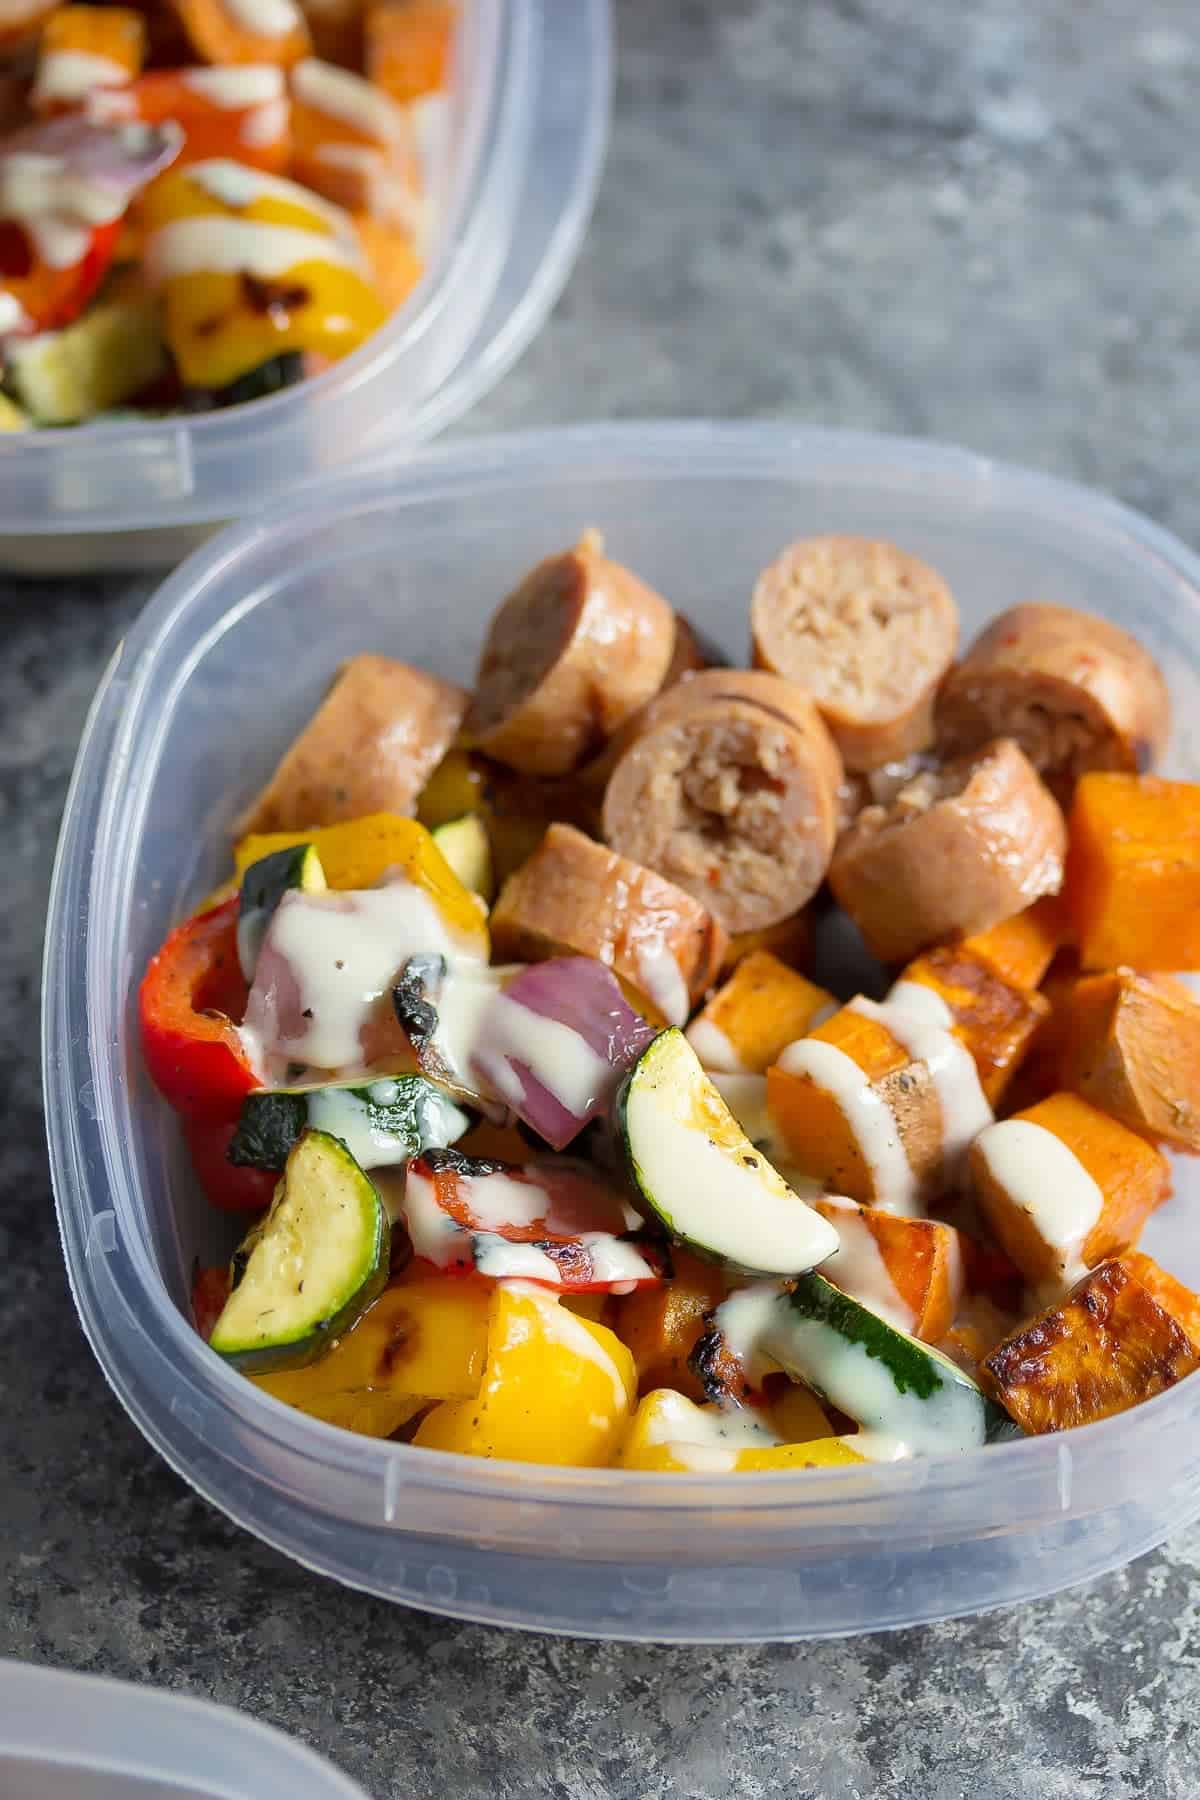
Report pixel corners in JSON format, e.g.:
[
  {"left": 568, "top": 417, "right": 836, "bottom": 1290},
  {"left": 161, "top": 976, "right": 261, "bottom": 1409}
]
[{"left": 491, "top": 824, "right": 725, "bottom": 1024}]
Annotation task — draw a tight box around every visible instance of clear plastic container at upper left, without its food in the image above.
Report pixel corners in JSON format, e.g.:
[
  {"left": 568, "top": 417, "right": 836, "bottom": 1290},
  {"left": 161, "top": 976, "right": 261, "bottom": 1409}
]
[{"left": 0, "top": 0, "right": 612, "bottom": 574}]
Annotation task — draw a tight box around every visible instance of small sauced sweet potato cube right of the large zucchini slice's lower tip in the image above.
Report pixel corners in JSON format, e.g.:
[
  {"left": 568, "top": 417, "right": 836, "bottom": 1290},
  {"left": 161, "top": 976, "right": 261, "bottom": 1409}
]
[{"left": 810, "top": 1193, "right": 963, "bottom": 1343}]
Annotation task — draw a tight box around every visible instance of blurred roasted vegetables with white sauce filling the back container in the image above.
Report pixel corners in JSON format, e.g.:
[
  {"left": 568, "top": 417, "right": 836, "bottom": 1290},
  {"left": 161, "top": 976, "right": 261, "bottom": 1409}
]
[{"left": 0, "top": 0, "right": 455, "bottom": 430}]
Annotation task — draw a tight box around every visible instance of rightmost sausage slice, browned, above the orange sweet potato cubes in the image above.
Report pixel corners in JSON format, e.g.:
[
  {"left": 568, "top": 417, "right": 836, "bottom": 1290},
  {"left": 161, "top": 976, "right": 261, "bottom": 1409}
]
[{"left": 937, "top": 601, "right": 1171, "bottom": 799}]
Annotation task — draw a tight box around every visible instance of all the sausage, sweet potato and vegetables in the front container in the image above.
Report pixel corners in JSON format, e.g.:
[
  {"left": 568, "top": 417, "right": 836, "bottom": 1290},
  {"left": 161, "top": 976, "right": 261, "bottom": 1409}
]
[{"left": 140, "top": 531, "right": 1200, "bottom": 1474}]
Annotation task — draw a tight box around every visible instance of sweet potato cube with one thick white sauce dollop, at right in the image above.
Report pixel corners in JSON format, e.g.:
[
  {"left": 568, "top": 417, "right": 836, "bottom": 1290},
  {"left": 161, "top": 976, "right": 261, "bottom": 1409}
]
[{"left": 968, "top": 1093, "right": 1171, "bottom": 1291}]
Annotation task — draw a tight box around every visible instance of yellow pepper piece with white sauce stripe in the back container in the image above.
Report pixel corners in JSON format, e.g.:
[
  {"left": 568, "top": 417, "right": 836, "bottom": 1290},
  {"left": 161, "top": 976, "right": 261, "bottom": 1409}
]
[{"left": 142, "top": 160, "right": 387, "bottom": 389}]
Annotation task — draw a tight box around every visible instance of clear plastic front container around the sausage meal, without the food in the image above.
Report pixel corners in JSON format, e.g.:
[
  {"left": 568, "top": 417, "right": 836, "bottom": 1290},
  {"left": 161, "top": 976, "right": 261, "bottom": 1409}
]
[{"left": 45, "top": 423, "right": 1200, "bottom": 1640}]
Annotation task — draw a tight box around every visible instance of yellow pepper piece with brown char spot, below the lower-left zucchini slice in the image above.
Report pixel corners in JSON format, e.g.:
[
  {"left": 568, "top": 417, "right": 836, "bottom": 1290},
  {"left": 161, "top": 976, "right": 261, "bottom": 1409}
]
[{"left": 250, "top": 1276, "right": 491, "bottom": 1438}]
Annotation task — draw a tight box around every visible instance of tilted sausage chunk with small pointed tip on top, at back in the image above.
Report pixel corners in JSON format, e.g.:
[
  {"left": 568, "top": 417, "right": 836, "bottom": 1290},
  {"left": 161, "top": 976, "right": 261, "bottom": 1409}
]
[{"left": 468, "top": 533, "right": 676, "bottom": 776}]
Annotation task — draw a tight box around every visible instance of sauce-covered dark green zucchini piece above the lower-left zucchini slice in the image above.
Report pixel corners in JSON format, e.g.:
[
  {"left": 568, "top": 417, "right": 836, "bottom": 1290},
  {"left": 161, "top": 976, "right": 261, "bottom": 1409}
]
[{"left": 227, "top": 1075, "right": 471, "bottom": 1168}]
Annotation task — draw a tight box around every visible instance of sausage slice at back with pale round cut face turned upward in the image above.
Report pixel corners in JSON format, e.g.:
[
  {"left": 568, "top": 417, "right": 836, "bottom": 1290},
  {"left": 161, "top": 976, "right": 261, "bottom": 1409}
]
[{"left": 750, "top": 536, "right": 959, "bottom": 772}]
